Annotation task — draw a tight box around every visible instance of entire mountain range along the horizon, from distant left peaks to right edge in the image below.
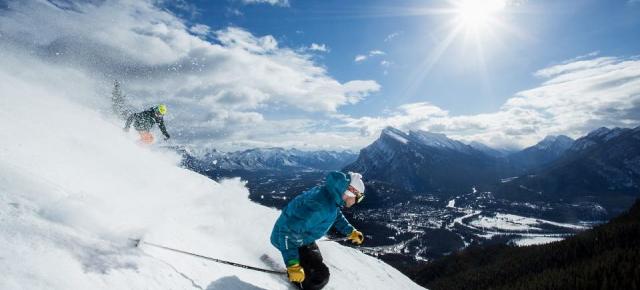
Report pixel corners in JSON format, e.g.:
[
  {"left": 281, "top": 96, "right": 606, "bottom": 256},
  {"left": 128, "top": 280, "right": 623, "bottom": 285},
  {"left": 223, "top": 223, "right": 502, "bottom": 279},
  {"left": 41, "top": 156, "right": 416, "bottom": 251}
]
[{"left": 177, "top": 123, "right": 640, "bottom": 214}]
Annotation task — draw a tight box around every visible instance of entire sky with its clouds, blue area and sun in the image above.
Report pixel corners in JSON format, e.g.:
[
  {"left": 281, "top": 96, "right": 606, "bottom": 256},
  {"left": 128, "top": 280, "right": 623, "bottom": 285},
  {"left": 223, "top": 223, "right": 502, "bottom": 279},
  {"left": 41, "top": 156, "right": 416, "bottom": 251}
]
[{"left": 0, "top": 0, "right": 640, "bottom": 150}]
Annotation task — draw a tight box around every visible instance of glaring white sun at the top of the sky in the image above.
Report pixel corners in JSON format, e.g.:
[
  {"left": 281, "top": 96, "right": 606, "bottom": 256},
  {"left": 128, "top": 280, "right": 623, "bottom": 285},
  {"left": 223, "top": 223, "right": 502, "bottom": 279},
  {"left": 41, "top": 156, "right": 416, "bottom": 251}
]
[{"left": 454, "top": 0, "right": 507, "bottom": 31}]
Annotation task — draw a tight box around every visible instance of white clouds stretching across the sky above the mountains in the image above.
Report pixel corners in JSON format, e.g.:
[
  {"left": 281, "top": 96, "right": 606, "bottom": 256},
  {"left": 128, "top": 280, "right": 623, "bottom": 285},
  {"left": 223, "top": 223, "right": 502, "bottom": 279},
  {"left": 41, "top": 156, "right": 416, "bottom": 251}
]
[{"left": 0, "top": 0, "right": 640, "bottom": 149}]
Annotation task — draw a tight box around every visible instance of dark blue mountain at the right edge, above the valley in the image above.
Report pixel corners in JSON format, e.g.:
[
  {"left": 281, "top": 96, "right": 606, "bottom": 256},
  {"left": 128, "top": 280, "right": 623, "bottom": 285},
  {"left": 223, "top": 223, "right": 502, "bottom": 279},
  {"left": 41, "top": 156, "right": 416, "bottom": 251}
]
[{"left": 497, "top": 127, "right": 640, "bottom": 214}]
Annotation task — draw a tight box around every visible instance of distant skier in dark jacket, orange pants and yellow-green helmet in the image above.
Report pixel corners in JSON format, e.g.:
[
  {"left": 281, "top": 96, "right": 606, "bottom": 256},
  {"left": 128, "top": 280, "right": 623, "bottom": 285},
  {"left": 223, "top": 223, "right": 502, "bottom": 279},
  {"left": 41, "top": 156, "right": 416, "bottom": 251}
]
[{"left": 124, "top": 104, "right": 170, "bottom": 144}]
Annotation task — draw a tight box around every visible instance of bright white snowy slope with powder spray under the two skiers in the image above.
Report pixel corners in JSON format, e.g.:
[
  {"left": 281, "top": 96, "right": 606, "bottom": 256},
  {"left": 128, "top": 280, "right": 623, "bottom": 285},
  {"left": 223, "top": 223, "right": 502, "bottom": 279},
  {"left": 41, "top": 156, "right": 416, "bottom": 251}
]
[{"left": 0, "top": 48, "right": 420, "bottom": 290}]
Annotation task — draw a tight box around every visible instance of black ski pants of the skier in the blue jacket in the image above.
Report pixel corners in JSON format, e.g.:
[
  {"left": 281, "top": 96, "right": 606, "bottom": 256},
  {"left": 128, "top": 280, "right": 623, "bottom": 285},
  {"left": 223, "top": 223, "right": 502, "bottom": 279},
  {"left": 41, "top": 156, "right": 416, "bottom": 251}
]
[{"left": 294, "top": 243, "right": 329, "bottom": 290}]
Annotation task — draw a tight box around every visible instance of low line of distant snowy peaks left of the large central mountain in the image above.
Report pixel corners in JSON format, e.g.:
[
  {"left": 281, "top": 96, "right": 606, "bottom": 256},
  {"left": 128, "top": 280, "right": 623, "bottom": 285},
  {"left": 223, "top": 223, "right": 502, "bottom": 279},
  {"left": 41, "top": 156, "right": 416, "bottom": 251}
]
[{"left": 185, "top": 148, "right": 357, "bottom": 170}]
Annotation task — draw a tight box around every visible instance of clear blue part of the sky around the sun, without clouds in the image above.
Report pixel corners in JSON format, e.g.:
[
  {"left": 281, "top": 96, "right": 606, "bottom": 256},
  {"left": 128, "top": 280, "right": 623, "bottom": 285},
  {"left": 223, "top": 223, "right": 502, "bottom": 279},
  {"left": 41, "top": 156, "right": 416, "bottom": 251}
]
[{"left": 177, "top": 0, "right": 640, "bottom": 116}]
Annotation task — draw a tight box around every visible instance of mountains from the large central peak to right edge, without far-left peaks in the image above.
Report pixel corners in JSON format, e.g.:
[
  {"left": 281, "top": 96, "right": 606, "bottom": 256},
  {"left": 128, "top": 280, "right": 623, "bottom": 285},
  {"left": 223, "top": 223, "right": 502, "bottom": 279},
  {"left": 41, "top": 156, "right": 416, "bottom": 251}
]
[{"left": 344, "top": 127, "right": 640, "bottom": 212}]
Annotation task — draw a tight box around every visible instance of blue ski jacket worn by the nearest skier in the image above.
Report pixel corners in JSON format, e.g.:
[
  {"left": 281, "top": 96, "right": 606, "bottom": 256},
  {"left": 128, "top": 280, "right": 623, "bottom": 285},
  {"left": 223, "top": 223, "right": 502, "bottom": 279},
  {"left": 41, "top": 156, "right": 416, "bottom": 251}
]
[{"left": 271, "top": 171, "right": 354, "bottom": 266}]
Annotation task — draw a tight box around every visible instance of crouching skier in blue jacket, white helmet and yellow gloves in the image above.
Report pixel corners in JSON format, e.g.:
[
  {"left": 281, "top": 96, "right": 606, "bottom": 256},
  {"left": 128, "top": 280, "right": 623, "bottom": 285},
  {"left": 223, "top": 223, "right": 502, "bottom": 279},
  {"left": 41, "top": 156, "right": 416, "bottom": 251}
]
[{"left": 271, "top": 172, "right": 364, "bottom": 289}]
